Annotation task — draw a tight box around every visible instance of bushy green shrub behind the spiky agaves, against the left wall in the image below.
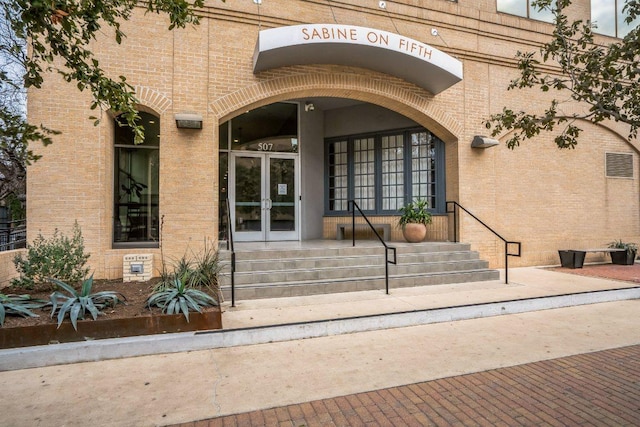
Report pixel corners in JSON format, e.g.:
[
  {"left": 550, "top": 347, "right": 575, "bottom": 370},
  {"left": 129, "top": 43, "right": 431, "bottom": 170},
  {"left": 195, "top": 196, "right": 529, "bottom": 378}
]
[{"left": 11, "top": 222, "right": 89, "bottom": 289}]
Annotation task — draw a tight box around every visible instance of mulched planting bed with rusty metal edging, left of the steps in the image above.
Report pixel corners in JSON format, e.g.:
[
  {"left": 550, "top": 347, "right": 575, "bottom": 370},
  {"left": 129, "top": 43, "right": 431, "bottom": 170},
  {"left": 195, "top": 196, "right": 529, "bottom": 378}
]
[{"left": 0, "top": 279, "right": 222, "bottom": 348}]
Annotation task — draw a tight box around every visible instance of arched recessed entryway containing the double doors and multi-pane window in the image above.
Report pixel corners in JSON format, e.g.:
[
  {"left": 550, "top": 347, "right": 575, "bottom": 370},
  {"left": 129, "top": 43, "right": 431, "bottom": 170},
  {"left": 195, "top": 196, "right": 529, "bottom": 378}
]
[{"left": 219, "top": 97, "right": 458, "bottom": 242}]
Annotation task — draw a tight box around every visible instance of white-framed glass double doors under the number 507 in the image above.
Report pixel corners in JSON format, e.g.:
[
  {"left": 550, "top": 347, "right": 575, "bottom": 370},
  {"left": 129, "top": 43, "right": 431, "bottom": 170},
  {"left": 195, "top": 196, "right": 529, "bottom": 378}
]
[{"left": 229, "top": 152, "right": 300, "bottom": 242}]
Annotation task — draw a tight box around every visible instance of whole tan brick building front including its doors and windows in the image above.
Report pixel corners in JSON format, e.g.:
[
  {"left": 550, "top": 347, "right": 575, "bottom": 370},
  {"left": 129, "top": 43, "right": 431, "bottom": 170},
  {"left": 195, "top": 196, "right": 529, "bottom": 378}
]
[{"left": 27, "top": 0, "right": 640, "bottom": 278}]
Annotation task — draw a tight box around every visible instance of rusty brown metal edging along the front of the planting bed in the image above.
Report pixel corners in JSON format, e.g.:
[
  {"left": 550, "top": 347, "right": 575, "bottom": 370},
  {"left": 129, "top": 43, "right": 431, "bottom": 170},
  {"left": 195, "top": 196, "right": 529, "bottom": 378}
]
[{"left": 0, "top": 308, "right": 222, "bottom": 348}]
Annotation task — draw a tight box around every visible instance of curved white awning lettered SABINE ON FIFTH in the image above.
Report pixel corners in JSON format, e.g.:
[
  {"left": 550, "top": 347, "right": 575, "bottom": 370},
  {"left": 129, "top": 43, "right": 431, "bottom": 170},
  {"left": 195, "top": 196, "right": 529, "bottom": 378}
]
[{"left": 253, "top": 24, "right": 462, "bottom": 95}]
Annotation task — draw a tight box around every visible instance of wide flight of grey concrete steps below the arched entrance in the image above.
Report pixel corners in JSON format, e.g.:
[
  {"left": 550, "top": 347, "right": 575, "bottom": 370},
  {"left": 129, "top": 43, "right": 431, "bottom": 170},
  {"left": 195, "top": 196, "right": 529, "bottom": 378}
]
[{"left": 220, "top": 241, "right": 499, "bottom": 299}]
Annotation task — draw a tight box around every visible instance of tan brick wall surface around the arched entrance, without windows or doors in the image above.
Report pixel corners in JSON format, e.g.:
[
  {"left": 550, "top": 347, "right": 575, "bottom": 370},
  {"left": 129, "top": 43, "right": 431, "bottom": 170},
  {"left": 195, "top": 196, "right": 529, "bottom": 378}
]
[{"left": 28, "top": 0, "right": 640, "bottom": 278}]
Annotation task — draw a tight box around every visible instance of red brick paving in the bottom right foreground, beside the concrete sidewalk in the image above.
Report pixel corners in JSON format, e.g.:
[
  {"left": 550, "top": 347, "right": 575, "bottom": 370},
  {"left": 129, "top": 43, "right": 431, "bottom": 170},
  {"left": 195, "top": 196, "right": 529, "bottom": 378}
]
[{"left": 172, "top": 345, "right": 640, "bottom": 427}]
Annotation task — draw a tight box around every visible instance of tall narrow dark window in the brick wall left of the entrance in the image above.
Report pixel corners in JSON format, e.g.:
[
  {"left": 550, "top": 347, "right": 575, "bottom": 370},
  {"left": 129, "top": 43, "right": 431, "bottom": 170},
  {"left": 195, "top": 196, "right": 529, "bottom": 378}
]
[{"left": 113, "top": 112, "right": 160, "bottom": 247}]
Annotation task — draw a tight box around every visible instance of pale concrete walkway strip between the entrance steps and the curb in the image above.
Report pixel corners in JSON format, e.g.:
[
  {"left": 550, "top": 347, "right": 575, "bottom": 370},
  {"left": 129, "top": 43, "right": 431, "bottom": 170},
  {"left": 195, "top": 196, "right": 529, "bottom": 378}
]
[{"left": 223, "top": 267, "right": 640, "bottom": 329}]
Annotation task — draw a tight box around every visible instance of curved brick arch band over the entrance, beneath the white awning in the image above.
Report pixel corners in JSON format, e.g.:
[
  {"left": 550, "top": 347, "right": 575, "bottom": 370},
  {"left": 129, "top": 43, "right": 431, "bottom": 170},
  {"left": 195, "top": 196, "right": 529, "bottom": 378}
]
[{"left": 209, "top": 73, "right": 463, "bottom": 142}]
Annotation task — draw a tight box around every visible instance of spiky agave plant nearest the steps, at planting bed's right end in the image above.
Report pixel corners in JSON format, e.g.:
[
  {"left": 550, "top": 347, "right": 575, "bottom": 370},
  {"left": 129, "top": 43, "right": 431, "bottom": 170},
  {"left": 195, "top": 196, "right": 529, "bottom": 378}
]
[{"left": 145, "top": 277, "right": 218, "bottom": 322}]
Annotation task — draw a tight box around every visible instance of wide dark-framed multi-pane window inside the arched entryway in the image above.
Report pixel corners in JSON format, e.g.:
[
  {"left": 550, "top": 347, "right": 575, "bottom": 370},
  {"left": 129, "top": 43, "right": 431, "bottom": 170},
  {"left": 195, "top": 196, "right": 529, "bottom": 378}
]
[{"left": 325, "top": 129, "right": 444, "bottom": 215}]
